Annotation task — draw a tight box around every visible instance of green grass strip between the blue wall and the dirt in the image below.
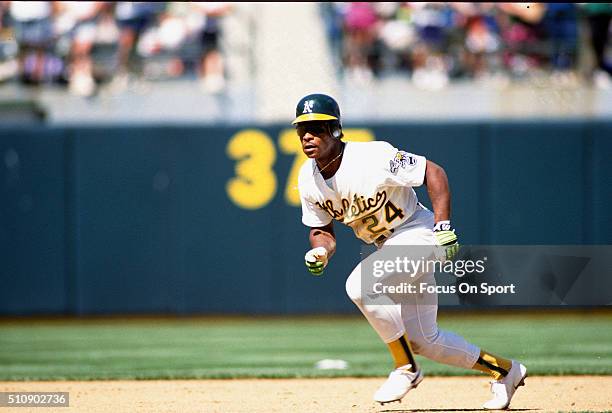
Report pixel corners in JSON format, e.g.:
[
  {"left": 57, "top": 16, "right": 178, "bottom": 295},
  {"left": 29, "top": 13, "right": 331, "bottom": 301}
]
[{"left": 0, "top": 312, "right": 612, "bottom": 380}]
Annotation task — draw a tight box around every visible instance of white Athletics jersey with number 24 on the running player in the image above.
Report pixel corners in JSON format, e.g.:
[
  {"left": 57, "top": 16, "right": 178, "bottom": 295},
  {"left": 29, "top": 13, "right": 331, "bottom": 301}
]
[{"left": 298, "top": 141, "right": 426, "bottom": 244}]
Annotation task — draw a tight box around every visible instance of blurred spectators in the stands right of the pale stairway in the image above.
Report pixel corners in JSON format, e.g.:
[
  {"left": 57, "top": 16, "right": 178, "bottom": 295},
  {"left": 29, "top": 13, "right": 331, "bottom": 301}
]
[{"left": 321, "top": 2, "right": 612, "bottom": 89}]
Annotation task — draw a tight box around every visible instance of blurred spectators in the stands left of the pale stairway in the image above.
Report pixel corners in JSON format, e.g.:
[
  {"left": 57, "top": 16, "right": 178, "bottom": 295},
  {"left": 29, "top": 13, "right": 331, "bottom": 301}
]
[{"left": 0, "top": 1, "right": 232, "bottom": 96}]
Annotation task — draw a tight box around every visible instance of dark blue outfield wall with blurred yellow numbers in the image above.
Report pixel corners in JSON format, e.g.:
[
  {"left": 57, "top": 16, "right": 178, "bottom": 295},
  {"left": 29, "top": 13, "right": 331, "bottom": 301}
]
[{"left": 0, "top": 121, "right": 612, "bottom": 315}]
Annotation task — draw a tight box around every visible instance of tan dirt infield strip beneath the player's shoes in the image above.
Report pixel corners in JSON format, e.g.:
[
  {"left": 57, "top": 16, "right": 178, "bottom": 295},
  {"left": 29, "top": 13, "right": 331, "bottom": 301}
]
[{"left": 0, "top": 376, "right": 612, "bottom": 413}]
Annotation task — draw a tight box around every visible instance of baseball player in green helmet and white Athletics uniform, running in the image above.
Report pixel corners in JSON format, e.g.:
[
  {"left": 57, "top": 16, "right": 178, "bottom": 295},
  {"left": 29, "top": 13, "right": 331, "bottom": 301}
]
[{"left": 293, "top": 94, "right": 527, "bottom": 409}]
